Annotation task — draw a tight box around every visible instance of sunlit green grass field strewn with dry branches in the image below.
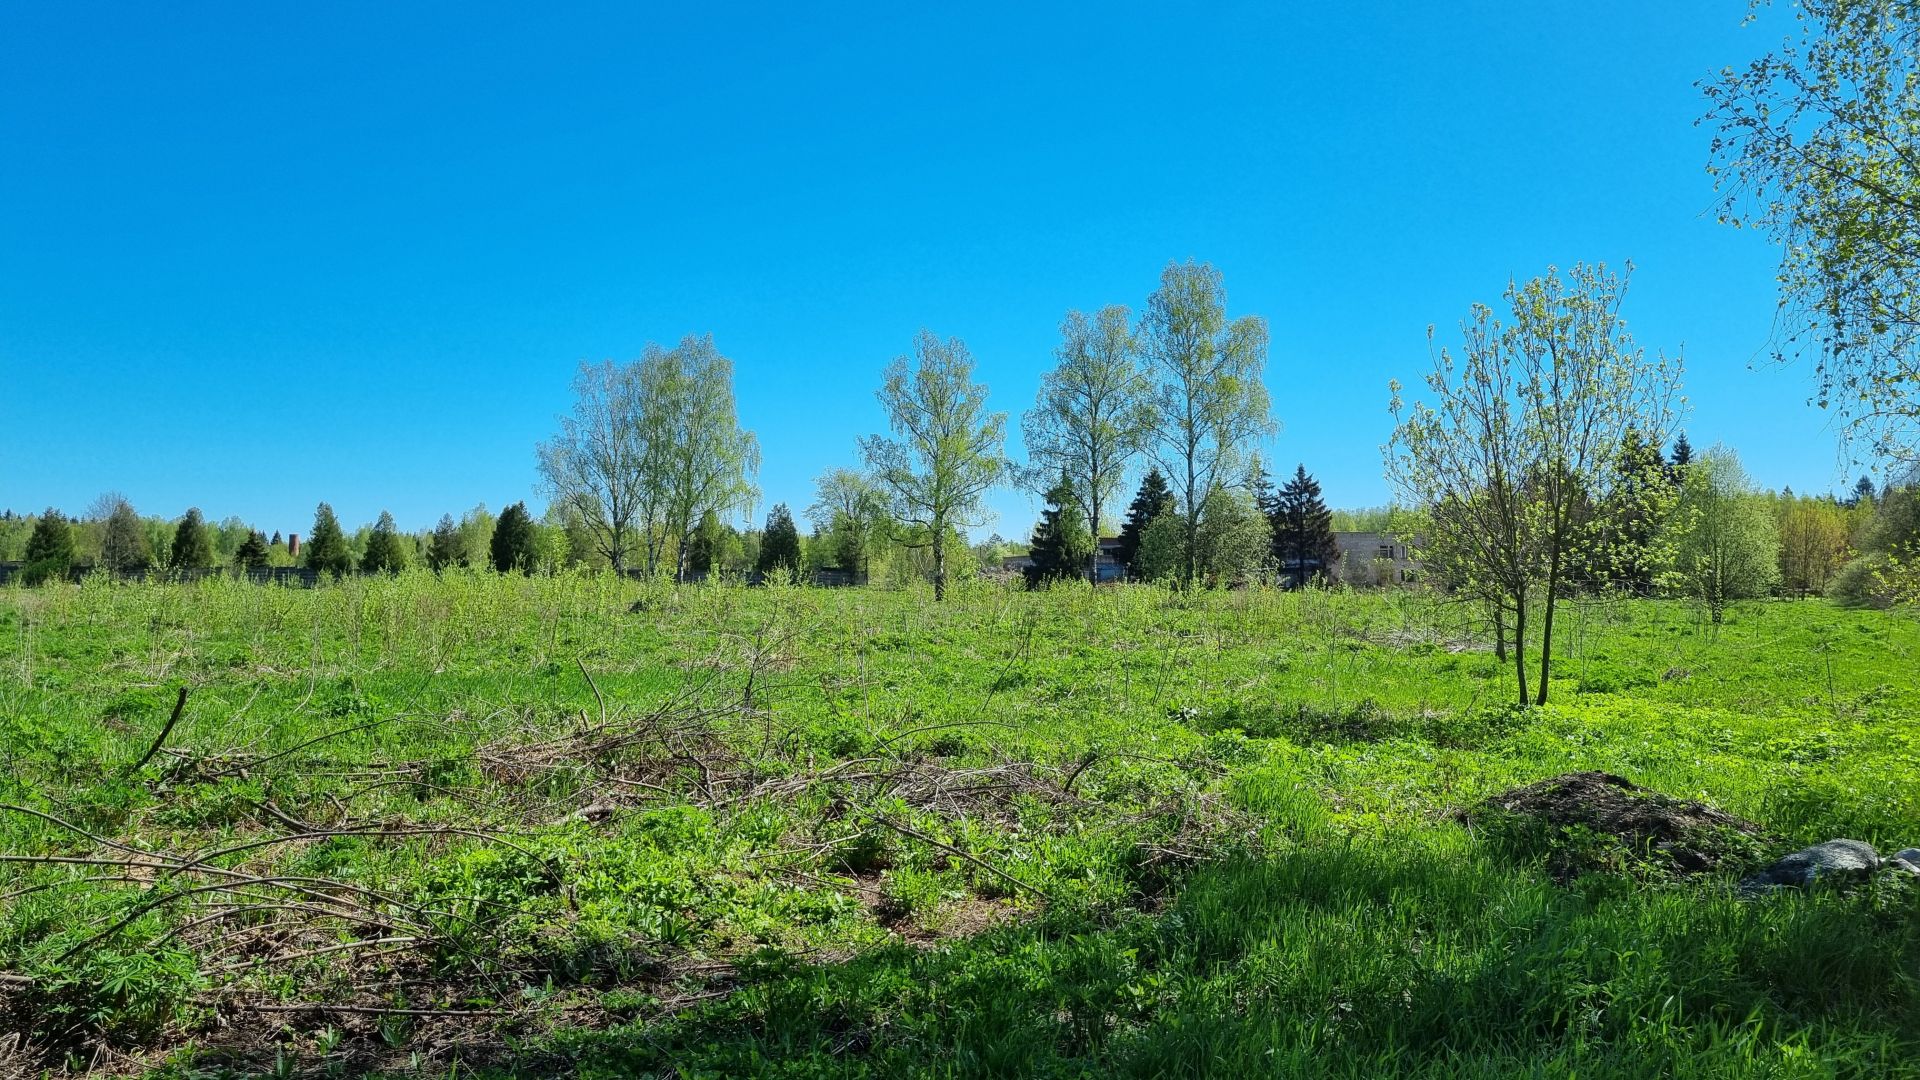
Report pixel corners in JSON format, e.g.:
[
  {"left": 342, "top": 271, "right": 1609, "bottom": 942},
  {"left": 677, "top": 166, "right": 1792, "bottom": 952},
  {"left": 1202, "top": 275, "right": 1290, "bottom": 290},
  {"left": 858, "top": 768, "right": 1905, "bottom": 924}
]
[{"left": 0, "top": 575, "right": 1920, "bottom": 1076}]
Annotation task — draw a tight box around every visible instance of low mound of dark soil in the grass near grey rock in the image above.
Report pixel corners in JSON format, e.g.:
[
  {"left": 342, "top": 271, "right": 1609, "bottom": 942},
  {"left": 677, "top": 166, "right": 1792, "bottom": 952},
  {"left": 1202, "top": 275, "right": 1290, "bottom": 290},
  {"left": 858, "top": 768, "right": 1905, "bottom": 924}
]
[{"left": 1465, "top": 773, "right": 1764, "bottom": 880}]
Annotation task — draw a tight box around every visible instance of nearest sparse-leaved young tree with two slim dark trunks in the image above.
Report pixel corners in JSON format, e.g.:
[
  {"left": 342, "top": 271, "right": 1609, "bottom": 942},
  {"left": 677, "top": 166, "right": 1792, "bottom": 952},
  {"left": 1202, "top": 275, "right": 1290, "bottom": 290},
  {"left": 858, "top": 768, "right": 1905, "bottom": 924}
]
[{"left": 1384, "top": 265, "right": 1680, "bottom": 705}]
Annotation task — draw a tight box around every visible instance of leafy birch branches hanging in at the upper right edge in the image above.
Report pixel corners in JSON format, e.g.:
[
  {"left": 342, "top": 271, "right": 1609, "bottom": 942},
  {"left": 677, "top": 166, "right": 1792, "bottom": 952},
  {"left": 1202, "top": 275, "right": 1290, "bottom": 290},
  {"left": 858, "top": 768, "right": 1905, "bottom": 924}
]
[{"left": 1703, "top": 0, "right": 1920, "bottom": 455}]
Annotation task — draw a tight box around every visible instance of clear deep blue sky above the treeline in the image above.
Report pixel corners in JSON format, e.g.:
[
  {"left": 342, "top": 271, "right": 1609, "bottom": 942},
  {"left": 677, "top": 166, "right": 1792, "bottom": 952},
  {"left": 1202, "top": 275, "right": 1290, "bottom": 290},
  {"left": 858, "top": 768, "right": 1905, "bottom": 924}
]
[{"left": 0, "top": 0, "right": 1859, "bottom": 536}]
